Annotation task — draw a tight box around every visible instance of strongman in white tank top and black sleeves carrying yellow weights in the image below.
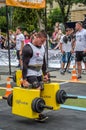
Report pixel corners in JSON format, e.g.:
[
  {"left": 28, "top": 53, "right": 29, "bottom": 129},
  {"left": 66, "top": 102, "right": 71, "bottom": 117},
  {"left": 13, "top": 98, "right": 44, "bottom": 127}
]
[{"left": 22, "top": 31, "right": 48, "bottom": 121}]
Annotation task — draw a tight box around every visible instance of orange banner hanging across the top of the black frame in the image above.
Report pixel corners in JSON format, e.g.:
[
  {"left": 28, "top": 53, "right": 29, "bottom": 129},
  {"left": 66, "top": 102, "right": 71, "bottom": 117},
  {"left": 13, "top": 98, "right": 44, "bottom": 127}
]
[{"left": 6, "top": 0, "right": 45, "bottom": 9}]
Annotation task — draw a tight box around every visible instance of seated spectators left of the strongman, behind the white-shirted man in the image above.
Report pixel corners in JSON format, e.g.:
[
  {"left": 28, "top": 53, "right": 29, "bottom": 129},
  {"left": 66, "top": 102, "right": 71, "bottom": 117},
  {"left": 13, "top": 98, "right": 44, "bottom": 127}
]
[{"left": 0, "top": 30, "right": 36, "bottom": 49}]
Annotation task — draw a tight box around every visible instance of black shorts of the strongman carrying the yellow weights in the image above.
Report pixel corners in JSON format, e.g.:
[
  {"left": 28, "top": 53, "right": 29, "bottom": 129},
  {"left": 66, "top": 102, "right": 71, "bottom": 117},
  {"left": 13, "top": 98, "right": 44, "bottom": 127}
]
[{"left": 27, "top": 76, "right": 43, "bottom": 88}]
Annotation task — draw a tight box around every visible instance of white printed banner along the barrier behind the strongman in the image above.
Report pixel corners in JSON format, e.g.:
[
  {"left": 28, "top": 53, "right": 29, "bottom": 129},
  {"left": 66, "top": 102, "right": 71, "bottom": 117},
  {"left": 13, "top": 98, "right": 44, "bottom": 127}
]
[{"left": 0, "top": 49, "right": 84, "bottom": 69}]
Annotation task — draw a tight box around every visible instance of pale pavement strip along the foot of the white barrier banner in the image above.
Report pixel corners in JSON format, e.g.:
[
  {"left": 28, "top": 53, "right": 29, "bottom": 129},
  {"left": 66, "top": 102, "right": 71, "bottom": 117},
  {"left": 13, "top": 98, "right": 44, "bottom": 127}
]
[{"left": 0, "top": 66, "right": 86, "bottom": 84}]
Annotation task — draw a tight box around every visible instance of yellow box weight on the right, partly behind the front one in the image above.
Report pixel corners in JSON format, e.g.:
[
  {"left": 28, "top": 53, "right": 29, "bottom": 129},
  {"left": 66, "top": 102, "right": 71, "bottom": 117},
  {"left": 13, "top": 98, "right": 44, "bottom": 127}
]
[{"left": 41, "top": 83, "right": 60, "bottom": 110}]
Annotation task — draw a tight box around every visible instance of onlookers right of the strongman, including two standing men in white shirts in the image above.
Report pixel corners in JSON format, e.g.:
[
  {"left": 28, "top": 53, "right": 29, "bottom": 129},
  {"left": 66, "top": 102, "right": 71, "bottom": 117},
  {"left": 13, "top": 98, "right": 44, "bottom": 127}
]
[{"left": 50, "top": 22, "right": 86, "bottom": 79}]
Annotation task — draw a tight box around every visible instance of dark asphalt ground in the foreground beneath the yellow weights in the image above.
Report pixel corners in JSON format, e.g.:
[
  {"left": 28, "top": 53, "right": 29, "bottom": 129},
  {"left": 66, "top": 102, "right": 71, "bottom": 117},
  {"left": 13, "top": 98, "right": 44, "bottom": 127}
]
[{"left": 0, "top": 100, "right": 86, "bottom": 130}]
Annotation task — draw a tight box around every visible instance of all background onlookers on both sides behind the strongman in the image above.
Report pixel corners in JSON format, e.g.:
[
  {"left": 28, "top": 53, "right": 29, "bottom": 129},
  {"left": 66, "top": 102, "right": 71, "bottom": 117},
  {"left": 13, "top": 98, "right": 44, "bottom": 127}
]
[{"left": 0, "top": 22, "right": 86, "bottom": 78}]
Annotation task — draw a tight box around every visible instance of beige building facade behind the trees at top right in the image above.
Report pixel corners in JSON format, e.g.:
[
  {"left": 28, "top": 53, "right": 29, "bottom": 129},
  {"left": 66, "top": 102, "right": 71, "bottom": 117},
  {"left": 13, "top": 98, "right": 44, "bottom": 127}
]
[{"left": 47, "top": 1, "right": 86, "bottom": 22}]
